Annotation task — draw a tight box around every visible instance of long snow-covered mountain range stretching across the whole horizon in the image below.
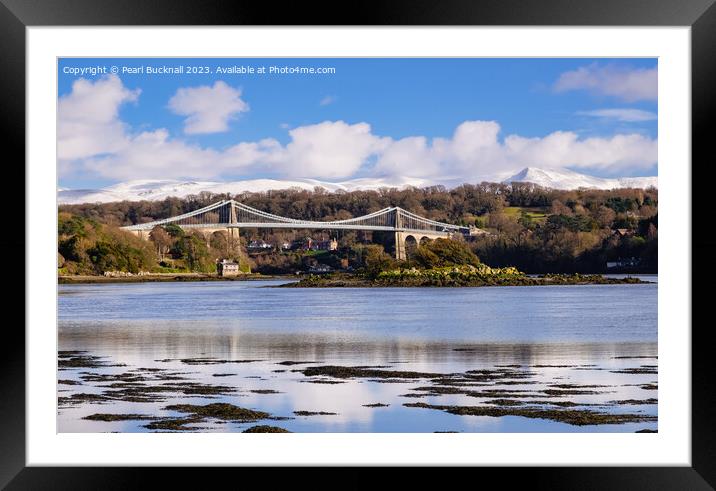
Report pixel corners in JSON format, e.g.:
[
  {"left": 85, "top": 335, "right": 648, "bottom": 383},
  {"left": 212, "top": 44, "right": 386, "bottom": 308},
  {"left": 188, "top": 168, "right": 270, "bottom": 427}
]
[{"left": 57, "top": 167, "right": 657, "bottom": 205}]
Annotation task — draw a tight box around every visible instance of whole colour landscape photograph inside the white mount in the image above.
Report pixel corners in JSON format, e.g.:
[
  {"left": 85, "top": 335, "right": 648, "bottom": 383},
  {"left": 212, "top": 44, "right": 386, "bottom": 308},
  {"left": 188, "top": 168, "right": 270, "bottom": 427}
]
[{"left": 57, "top": 56, "right": 660, "bottom": 439}]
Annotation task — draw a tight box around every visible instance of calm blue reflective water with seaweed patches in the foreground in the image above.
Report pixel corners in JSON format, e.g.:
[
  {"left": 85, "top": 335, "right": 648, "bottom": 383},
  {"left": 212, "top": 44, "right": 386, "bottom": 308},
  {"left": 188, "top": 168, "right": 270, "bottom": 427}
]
[{"left": 58, "top": 276, "right": 657, "bottom": 432}]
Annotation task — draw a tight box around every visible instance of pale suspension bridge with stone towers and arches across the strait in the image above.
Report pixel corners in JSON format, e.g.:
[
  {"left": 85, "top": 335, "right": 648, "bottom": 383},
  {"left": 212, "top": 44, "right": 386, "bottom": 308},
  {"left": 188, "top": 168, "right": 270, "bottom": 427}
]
[{"left": 122, "top": 199, "right": 483, "bottom": 259}]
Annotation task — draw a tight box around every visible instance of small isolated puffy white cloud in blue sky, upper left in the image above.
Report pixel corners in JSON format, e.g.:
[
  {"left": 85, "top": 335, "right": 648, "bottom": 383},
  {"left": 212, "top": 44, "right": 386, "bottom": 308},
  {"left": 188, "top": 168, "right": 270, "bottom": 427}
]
[{"left": 169, "top": 80, "right": 249, "bottom": 134}]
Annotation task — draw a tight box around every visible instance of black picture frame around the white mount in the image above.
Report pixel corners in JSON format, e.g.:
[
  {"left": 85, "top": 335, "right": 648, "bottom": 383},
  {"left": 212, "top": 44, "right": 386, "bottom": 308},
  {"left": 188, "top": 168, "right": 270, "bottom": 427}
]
[{"left": 0, "top": 0, "right": 716, "bottom": 490}]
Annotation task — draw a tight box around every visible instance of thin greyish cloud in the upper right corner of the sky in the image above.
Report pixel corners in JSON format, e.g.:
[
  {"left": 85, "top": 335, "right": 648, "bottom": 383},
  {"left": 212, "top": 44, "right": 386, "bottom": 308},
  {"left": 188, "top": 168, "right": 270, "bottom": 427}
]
[{"left": 554, "top": 63, "right": 658, "bottom": 102}]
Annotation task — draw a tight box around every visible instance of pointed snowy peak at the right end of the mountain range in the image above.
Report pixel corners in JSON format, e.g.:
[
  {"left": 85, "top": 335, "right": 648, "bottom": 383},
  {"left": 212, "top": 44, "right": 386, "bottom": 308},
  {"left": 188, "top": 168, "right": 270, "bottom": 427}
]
[{"left": 502, "top": 167, "right": 658, "bottom": 189}]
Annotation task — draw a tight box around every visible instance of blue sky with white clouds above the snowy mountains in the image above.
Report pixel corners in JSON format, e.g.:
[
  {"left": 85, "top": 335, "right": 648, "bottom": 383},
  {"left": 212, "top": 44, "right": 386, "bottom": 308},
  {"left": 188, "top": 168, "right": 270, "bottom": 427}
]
[{"left": 58, "top": 58, "right": 657, "bottom": 188}]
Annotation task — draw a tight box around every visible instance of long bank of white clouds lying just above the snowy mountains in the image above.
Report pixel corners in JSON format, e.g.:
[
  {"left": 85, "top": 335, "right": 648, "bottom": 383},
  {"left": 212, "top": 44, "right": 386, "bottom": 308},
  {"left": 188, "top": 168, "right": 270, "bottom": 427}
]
[{"left": 58, "top": 77, "right": 657, "bottom": 182}]
